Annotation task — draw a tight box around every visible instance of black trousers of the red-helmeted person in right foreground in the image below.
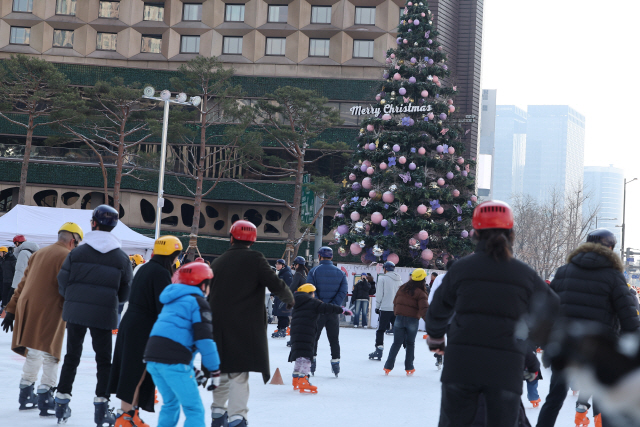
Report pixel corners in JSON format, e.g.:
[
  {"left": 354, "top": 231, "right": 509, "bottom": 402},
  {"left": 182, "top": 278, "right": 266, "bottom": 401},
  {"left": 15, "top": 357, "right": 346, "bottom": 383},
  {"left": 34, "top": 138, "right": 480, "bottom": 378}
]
[{"left": 438, "top": 383, "right": 520, "bottom": 427}]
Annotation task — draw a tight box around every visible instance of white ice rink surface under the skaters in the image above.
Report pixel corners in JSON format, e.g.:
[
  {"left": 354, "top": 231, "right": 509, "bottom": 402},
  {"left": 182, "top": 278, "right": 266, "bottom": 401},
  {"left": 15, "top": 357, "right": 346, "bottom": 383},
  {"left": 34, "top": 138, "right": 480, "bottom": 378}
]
[{"left": 0, "top": 325, "right": 576, "bottom": 427}]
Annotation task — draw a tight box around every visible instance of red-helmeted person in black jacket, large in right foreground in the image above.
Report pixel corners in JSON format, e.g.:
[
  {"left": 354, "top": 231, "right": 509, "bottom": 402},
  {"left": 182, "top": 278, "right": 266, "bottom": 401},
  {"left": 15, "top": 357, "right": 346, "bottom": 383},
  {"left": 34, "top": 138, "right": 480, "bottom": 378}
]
[{"left": 425, "top": 201, "right": 560, "bottom": 427}]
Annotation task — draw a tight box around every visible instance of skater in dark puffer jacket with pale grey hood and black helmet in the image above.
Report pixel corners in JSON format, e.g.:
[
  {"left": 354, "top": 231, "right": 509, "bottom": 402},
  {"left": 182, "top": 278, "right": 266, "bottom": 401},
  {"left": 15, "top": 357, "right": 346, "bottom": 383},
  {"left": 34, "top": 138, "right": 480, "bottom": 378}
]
[{"left": 56, "top": 205, "right": 133, "bottom": 425}]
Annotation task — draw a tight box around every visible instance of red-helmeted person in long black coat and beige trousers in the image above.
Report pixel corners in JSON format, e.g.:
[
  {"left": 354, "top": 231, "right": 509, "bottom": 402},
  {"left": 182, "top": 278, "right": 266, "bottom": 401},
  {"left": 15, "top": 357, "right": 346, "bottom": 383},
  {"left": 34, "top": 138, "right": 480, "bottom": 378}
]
[{"left": 209, "top": 220, "right": 294, "bottom": 427}]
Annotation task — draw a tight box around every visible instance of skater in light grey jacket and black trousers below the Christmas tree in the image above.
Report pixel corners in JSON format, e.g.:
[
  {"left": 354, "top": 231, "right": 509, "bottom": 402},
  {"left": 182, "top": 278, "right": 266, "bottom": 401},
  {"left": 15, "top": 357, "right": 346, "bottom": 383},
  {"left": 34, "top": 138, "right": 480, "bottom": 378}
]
[{"left": 369, "top": 261, "right": 402, "bottom": 360}]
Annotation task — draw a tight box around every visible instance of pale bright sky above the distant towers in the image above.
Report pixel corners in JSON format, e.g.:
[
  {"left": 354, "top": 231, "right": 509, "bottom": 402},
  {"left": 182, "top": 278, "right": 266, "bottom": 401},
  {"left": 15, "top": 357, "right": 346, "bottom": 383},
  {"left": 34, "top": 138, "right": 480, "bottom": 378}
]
[{"left": 482, "top": 0, "right": 640, "bottom": 249}]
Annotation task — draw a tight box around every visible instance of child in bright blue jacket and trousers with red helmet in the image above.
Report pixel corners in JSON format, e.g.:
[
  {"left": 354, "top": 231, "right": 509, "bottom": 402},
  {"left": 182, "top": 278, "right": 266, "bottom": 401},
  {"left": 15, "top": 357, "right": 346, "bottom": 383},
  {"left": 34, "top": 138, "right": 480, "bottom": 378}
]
[{"left": 144, "top": 262, "right": 220, "bottom": 427}]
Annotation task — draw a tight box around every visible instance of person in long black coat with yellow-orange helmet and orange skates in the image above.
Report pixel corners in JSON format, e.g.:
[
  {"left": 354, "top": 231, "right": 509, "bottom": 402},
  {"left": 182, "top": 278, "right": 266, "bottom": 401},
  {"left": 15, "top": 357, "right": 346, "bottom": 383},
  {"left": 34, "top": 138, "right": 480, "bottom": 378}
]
[{"left": 109, "top": 236, "right": 182, "bottom": 427}]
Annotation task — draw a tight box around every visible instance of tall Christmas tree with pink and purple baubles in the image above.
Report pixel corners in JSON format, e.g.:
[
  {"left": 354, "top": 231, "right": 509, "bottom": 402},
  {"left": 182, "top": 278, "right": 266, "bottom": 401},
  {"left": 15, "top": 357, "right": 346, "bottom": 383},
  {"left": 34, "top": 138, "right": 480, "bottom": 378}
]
[{"left": 335, "top": 2, "right": 477, "bottom": 268}]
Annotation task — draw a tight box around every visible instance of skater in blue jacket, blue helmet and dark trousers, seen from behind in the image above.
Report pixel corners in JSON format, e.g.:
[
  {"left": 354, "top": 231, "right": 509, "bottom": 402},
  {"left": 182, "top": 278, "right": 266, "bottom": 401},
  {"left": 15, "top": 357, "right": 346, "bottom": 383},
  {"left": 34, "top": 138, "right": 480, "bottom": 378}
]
[{"left": 307, "top": 246, "right": 347, "bottom": 377}]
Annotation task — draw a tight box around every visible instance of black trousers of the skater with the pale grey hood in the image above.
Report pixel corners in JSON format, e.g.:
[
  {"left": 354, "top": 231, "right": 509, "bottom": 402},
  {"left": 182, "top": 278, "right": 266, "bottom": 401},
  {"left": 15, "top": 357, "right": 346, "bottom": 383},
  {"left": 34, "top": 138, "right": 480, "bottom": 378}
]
[{"left": 58, "top": 323, "right": 112, "bottom": 398}]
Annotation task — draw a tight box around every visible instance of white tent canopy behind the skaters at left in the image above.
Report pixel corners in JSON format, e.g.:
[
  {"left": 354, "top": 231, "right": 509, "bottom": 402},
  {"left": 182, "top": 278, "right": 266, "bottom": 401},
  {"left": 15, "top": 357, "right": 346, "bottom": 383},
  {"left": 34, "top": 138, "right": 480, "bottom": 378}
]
[{"left": 0, "top": 205, "right": 154, "bottom": 259}]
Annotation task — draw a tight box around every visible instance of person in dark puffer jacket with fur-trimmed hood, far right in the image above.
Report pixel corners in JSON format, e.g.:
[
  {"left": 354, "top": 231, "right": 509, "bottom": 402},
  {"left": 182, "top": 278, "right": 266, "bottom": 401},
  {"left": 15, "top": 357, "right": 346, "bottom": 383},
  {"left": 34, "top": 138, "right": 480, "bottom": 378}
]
[{"left": 537, "top": 229, "right": 640, "bottom": 427}]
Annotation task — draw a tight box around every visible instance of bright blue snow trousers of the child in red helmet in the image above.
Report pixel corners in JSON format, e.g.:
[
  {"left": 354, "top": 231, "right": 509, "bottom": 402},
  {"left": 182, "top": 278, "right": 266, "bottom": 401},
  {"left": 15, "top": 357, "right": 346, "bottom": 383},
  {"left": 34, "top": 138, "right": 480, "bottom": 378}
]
[{"left": 147, "top": 362, "right": 205, "bottom": 427}]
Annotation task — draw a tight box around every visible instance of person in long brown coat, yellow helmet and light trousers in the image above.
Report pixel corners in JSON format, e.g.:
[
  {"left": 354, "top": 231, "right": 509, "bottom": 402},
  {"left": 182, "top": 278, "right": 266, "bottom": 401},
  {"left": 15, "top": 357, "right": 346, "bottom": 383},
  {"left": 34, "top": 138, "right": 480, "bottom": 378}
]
[{"left": 3, "top": 222, "right": 83, "bottom": 416}]
